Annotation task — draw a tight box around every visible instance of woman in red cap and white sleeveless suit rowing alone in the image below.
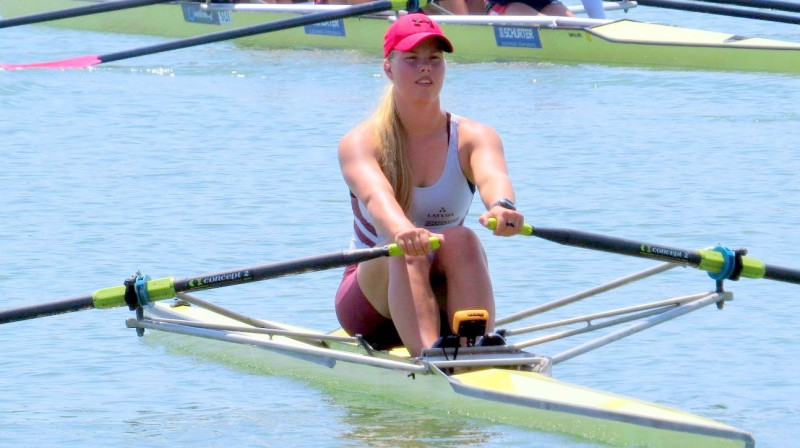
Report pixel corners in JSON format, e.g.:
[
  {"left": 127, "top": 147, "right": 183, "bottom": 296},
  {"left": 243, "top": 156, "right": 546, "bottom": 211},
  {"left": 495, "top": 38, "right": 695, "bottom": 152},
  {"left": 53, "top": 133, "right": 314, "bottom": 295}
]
[{"left": 336, "top": 13, "right": 524, "bottom": 356}]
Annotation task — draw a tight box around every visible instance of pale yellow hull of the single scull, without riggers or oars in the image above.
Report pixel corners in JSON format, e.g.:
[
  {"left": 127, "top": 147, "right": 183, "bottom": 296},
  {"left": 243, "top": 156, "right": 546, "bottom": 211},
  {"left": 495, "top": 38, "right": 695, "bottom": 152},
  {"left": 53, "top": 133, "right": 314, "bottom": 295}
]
[{"left": 139, "top": 304, "right": 755, "bottom": 448}]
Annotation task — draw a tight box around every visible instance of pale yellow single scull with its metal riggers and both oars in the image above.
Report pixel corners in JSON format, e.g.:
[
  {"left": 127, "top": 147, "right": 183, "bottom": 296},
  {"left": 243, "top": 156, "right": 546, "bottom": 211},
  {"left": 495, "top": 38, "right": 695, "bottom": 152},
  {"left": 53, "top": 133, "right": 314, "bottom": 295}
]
[{"left": 6, "top": 226, "right": 800, "bottom": 447}]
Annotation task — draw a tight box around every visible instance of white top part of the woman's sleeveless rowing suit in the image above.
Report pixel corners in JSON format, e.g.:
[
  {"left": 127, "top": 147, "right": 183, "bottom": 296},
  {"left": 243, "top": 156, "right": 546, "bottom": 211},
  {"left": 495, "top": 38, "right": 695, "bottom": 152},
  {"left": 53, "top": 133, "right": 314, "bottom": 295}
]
[{"left": 350, "top": 115, "right": 475, "bottom": 249}]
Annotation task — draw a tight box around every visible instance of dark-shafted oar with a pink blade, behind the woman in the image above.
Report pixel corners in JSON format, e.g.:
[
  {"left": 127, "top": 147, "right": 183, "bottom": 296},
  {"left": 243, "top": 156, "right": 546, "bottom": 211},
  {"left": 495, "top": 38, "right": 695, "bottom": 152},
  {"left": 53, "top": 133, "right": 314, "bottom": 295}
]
[{"left": 0, "top": 0, "right": 392, "bottom": 70}]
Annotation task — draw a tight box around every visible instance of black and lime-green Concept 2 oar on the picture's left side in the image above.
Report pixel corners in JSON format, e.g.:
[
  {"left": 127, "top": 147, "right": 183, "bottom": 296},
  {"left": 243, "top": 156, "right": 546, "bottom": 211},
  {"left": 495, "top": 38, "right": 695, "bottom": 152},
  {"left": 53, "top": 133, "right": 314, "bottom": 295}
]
[{"left": 0, "top": 238, "right": 439, "bottom": 324}]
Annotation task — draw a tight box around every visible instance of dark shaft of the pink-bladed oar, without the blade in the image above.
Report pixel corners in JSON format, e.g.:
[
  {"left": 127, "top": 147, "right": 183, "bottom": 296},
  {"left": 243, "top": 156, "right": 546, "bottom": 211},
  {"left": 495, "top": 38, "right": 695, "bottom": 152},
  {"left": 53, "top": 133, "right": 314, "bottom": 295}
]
[{"left": 98, "top": 1, "right": 392, "bottom": 62}]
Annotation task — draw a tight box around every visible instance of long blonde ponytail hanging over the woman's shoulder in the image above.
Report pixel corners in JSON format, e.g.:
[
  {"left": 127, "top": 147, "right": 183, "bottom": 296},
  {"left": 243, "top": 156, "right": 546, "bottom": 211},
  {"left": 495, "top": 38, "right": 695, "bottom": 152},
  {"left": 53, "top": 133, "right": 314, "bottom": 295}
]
[{"left": 371, "top": 84, "right": 413, "bottom": 212}]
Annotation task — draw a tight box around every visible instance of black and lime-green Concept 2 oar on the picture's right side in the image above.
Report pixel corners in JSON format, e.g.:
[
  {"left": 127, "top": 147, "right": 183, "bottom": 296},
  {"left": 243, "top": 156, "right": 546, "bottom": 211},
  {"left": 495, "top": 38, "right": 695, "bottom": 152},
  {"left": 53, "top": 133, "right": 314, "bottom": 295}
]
[{"left": 487, "top": 218, "right": 800, "bottom": 284}]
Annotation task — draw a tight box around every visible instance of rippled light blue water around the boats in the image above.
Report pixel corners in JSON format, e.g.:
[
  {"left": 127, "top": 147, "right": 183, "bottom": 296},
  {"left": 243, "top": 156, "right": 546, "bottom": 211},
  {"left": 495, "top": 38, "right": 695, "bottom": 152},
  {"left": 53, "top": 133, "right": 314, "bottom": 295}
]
[{"left": 0, "top": 5, "right": 800, "bottom": 448}]
